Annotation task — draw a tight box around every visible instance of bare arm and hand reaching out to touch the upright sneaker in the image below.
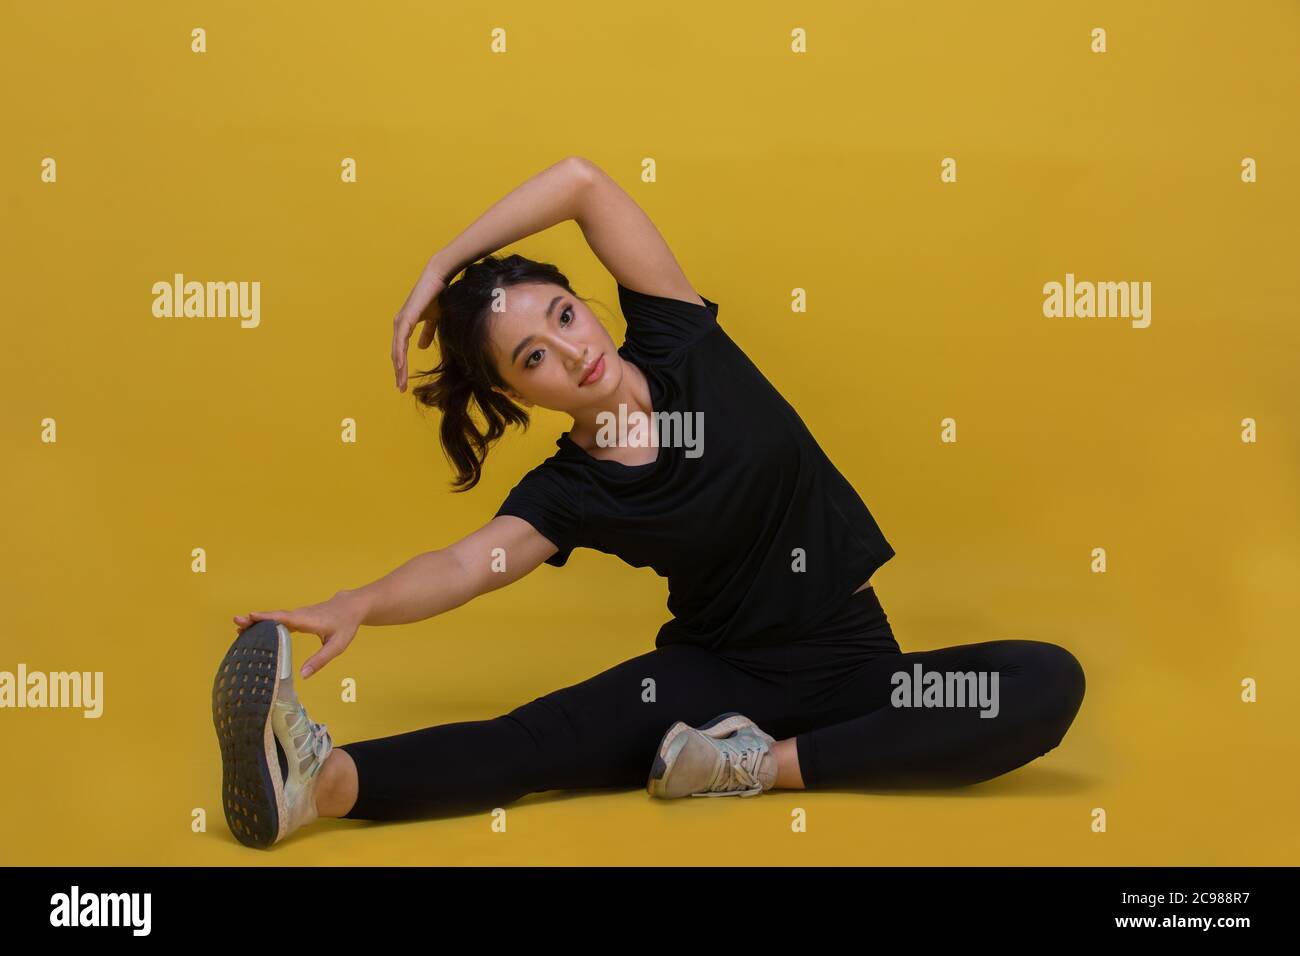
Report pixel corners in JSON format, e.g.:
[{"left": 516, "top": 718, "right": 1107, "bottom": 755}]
[{"left": 234, "top": 515, "right": 556, "bottom": 678}]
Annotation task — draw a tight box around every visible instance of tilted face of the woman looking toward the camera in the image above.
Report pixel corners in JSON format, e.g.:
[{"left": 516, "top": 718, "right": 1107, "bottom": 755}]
[{"left": 488, "top": 282, "right": 623, "bottom": 414}]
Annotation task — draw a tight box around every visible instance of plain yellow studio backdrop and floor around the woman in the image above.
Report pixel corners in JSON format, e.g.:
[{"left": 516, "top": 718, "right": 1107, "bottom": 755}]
[{"left": 0, "top": 0, "right": 1300, "bottom": 865}]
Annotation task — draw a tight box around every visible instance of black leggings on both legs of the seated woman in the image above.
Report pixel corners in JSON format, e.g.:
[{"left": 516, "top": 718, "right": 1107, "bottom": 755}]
[{"left": 341, "top": 588, "right": 1084, "bottom": 819}]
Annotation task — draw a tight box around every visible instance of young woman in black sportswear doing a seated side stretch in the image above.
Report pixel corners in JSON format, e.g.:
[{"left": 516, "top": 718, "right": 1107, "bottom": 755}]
[{"left": 213, "top": 157, "right": 1084, "bottom": 847}]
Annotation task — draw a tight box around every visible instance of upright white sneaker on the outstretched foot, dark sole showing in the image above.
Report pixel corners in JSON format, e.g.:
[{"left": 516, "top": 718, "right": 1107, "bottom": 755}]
[{"left": 212, "top": 620, "right": 334, "bottom": 849}]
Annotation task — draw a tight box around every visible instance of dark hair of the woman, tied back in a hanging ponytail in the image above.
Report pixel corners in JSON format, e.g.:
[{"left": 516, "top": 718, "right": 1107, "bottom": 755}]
[{"left": 411, "top": 255, "right": 586, "bottom": 492}]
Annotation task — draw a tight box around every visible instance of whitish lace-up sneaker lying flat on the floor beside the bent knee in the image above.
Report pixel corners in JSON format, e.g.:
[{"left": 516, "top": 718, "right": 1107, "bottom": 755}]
[{"left": 646, "top": 710, "right": 777, "bottom": 799}]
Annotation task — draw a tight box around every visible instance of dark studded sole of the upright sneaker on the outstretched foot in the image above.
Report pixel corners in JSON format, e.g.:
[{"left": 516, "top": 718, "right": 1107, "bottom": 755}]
[{"left": 212, "top": 620, "right": 289, "bottom": 849}]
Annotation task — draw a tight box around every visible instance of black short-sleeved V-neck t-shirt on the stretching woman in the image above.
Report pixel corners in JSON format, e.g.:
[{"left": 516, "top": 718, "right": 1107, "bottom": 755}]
[{"left": 497, "top": 285, "right": 894, "bottom": 649}]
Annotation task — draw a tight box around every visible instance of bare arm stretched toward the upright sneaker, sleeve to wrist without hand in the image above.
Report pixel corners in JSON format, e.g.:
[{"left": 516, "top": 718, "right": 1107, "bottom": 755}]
[{"left": 339, "top": 515, "right": 556, "bottom": 626}]
